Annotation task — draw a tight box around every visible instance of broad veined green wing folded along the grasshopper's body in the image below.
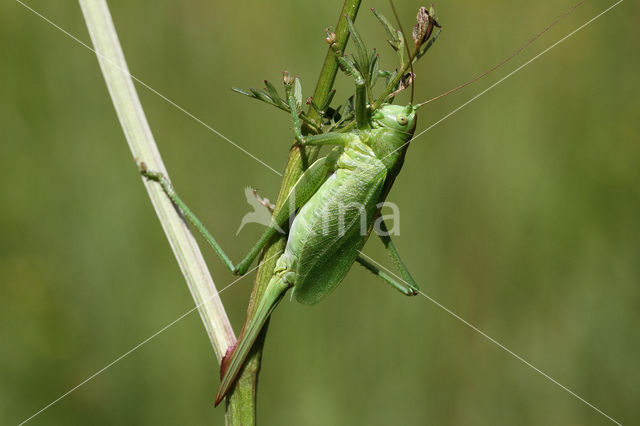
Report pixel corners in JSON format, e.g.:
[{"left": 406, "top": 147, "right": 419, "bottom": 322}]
[{"left": 287, "top": 152, "right": 386, "bottom": 304}]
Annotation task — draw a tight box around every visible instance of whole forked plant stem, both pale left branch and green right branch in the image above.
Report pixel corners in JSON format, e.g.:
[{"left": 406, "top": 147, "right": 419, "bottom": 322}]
[{"left": 79, "top": 0, "right": 361, "bottom": 425}]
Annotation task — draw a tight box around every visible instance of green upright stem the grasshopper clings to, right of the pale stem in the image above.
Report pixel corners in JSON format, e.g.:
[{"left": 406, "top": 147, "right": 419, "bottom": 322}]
[{"left": 224, "top": 0, "right": 361, "bottom": 425}]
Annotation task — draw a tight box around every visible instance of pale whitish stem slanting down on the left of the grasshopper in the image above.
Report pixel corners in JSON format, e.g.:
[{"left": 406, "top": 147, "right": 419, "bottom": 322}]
[{"left": 80, "top": 0, "right": 248, "bottom": 424}]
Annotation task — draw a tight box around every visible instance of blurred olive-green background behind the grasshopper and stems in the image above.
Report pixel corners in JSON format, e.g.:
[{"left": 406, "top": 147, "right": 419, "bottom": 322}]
[{"left": 0, "top": 0, "right": 640, "bottom": 425}]
